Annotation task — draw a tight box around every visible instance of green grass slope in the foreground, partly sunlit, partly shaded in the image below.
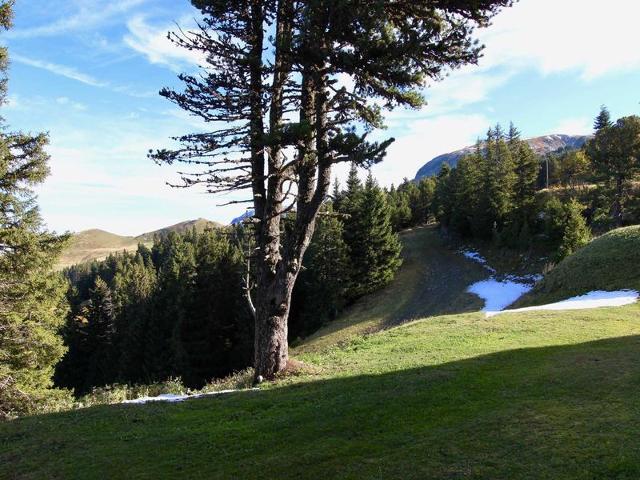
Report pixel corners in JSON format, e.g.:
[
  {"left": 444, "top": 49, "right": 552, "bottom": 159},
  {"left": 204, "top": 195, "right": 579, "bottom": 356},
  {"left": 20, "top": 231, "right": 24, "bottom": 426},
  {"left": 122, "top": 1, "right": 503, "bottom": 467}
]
[{"left": 0, "top": 230, "right": 640, "bottom": 479}]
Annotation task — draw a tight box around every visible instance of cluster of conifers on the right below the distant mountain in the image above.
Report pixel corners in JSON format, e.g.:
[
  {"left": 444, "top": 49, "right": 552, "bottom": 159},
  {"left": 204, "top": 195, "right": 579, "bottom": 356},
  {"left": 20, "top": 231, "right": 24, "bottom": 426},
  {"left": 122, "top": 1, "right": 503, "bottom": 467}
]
[{"left": 432, "top": 108, "right": 640, "bottom": 259}]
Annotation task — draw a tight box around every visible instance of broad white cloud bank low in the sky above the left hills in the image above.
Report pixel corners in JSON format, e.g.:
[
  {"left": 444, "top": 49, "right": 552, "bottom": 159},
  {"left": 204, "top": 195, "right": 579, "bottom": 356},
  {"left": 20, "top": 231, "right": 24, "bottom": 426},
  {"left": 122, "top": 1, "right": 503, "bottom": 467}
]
[{"left": 37, "top": 112, "right": 245, "bottom": 235}]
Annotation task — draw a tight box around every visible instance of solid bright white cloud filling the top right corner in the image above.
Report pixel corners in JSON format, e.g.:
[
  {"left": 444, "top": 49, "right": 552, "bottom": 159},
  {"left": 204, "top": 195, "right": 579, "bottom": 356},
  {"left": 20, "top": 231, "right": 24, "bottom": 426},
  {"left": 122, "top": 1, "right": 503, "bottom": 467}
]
[{"left": 479, "top": 0, "right": 640, "bottom": 80}]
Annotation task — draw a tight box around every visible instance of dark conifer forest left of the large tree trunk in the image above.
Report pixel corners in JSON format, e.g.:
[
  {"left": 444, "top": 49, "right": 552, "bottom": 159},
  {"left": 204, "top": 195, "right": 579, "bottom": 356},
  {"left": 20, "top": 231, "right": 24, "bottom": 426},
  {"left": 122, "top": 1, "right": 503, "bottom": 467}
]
[{"left": 55, "top": 230, "right": 253, "bottom": 394}]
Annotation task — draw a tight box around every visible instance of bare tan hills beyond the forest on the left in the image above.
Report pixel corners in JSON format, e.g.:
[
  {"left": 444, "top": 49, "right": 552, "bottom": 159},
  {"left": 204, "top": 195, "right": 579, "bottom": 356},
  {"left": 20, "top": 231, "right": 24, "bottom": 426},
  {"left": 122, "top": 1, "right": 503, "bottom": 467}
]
[{"left": 58, "top": 218, "right": 221, "bottom": 268}]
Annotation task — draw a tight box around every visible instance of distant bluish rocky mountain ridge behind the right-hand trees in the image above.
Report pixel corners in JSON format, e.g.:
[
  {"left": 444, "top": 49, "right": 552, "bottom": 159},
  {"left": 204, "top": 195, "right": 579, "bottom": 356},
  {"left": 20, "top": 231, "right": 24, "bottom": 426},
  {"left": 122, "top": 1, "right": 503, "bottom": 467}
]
[{"left": 415, "top": 135, "right": 589, "bottom": 180}]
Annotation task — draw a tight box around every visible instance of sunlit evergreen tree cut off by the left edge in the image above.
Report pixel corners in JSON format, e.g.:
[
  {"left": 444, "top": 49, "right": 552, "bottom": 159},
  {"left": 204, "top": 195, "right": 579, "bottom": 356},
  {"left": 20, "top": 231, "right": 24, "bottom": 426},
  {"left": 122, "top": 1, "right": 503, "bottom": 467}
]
[{"left": 0, "top": 1, "right": 66, "bottom": 418}]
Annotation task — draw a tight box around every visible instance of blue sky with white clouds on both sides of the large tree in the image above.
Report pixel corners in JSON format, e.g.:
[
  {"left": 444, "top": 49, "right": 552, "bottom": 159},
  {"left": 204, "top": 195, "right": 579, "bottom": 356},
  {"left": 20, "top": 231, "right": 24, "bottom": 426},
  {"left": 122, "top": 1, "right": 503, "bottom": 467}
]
[{"left": 0, "top": 0, "right": 640, "bottom": 235}]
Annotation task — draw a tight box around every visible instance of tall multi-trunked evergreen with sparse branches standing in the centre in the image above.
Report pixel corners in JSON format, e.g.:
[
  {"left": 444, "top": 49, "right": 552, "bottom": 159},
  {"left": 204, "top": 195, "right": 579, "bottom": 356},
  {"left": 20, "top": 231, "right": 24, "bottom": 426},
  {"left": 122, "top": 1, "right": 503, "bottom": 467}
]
[{"left": 152, "top": 0, "right": 512, "bottom": 380}]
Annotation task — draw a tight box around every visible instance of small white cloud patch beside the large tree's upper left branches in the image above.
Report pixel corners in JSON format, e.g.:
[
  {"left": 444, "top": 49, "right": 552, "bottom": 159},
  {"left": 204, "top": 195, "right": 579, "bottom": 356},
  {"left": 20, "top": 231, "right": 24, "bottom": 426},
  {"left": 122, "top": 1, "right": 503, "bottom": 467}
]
[{"left": 124, "top": 16, "right": 204, "bottom": 71}]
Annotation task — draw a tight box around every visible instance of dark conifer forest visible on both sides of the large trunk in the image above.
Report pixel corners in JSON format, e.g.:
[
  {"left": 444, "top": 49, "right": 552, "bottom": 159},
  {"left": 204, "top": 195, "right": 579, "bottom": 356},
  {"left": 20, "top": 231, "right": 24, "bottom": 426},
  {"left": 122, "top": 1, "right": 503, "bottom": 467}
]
[{"left": 55, "top": 168, "right": 400, "bottom": 395}]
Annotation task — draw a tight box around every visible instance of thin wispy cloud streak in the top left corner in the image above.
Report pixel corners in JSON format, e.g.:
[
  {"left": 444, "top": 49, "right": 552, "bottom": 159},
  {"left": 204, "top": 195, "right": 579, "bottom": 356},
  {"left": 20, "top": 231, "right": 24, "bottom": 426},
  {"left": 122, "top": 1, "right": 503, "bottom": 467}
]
[{"left": 6, "top": 0, "right": 147, "bottom": 38}]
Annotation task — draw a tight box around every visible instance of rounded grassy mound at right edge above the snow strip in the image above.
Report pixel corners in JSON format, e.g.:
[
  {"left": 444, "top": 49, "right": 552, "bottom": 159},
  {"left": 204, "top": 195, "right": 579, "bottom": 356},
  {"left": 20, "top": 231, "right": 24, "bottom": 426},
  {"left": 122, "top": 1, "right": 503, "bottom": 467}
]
[{"left": 517, "top": 226, "right": 640, "bottom": 307}]
